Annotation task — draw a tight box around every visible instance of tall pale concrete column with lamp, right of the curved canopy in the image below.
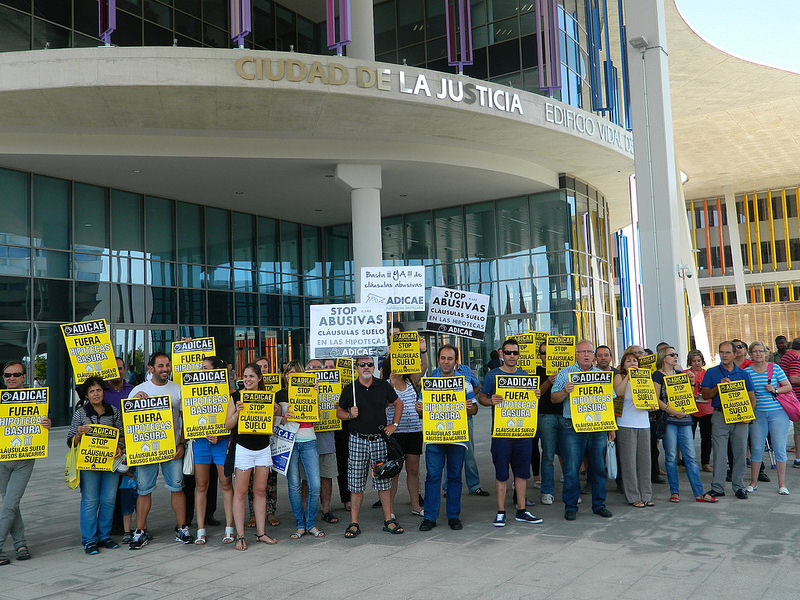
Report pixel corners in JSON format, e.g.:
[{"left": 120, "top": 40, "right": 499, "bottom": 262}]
[{"left": 625, "top": 0, "right": 691, "bottom": 356}]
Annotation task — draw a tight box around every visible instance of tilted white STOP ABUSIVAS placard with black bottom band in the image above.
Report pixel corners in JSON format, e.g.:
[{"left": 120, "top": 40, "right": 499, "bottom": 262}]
[{"left": 425, "top": 287, "right": 489, "bottom": 340}]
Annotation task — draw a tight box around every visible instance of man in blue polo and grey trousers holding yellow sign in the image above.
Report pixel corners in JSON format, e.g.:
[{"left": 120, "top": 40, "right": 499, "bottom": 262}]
[{"left": 700, "top": 342, "right": 755, "bottom": 500}]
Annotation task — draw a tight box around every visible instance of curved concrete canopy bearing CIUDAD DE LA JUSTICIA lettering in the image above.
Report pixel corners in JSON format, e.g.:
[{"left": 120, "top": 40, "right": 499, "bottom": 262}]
[{"left": 0, "top": 47, "right": 633, "bottom": 227}]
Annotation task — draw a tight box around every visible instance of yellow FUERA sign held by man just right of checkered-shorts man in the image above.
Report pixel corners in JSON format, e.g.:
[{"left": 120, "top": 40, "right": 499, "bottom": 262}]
[{"left": 422, "top": 377, "right": 469, "bottom": 444}]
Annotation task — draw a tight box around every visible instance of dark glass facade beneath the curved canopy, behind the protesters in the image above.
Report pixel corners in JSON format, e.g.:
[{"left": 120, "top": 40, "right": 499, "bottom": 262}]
[{"left": 0, "top": 169, "right": 613, "bottom": 423}]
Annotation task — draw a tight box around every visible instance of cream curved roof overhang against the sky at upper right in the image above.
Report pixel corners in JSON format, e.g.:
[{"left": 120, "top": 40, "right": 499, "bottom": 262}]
[{"left": 665, "top": 0, "right": 800, "bottom": 198}]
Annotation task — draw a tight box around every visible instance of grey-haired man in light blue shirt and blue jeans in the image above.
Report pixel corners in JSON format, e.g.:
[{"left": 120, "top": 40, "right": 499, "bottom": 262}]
[{"left": 550, "top": 340, "right": 616, "bottom": 521}]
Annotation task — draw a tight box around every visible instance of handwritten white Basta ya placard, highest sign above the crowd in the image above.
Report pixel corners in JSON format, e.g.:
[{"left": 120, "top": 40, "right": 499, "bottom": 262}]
[{"left": 361, "top": 267, "right": 425, "bottom": 312}]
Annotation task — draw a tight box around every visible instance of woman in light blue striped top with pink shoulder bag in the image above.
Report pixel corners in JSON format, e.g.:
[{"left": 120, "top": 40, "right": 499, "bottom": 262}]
[{"left": 745, "top": 342, "right": 792, "bottom": 496}]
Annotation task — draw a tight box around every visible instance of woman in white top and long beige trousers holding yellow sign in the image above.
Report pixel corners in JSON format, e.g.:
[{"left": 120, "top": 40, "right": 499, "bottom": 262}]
[{"left": 614, "top": 351, "right": 655, "bottom": 508}]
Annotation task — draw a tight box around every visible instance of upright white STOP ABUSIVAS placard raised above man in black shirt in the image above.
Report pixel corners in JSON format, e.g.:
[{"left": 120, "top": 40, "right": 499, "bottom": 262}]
[{"left": 309, "top": 304, "right": 389, "bottom": 359}]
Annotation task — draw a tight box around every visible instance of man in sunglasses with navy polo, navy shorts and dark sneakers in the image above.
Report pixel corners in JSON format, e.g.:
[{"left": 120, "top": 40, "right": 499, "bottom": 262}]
[{"left": 478, "top": 338, "right": 542, "bottom": 527}]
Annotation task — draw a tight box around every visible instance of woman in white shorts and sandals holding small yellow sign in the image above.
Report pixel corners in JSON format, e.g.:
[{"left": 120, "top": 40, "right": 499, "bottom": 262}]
[{"left": 225, "top": 363, "right": 282, "bottom": 550}]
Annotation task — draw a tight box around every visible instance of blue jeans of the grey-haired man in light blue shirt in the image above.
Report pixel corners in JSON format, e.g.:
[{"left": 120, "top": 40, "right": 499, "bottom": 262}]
[{"left": 557, "top": 417, "right": 608, "bottom": 512}]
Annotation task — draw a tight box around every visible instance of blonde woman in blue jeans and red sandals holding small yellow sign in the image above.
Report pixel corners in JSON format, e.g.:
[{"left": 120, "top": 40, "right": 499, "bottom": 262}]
[{"left": 653, "top": 346, "right": 717, "bottom": 503}]
